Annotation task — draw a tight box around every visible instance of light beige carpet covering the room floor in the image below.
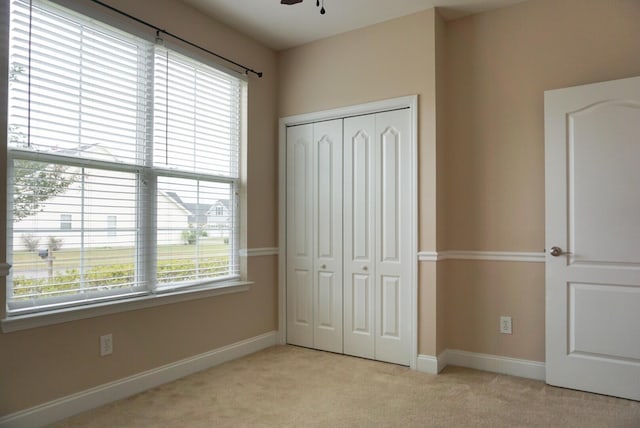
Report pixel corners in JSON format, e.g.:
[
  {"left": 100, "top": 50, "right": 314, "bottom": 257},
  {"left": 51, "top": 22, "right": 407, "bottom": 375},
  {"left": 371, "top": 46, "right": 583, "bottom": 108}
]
[{"left": 55, "top": 346, "right": 640, "bottom": 428}]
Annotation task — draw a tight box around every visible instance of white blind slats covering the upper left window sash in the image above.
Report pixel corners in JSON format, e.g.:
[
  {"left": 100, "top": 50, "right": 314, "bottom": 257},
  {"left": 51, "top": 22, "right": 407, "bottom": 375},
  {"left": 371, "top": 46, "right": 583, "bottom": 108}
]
[{"left": 9, "top": 1, "right": 153, "bottom": 164}]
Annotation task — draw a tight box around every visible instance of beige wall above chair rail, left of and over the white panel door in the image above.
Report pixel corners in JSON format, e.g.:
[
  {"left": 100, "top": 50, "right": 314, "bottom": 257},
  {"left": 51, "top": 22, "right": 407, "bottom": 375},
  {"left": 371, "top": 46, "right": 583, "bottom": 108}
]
[{"left": 443, "top": 0, "right": 640, "bottom": 251}]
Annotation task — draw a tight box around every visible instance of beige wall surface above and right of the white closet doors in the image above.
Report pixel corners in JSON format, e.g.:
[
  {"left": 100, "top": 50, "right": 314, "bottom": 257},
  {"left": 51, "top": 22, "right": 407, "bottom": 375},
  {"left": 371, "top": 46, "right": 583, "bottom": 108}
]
[{"left": 278, "top": 9, "right": 439, "bottom": 355}]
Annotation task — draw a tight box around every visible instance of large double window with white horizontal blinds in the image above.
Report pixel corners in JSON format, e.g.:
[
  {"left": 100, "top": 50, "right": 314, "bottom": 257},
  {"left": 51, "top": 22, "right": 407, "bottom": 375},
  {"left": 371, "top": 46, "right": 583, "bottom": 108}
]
[{"left": 7, "top": 0, "right": 245, "bottom": 316}]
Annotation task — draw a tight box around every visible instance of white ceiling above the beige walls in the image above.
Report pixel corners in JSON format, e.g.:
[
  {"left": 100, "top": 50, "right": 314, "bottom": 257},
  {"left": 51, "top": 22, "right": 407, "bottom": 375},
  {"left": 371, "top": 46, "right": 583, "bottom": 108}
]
[{"left": 181, "top": 0, "right": 524, "bottom": 50}]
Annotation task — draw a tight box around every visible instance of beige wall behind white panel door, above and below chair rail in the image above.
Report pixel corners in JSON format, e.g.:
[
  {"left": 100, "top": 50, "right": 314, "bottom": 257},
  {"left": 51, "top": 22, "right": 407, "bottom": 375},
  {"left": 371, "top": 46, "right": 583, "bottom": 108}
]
[{"left": 438, "top": 0, "right": 640, "bottom": 361}]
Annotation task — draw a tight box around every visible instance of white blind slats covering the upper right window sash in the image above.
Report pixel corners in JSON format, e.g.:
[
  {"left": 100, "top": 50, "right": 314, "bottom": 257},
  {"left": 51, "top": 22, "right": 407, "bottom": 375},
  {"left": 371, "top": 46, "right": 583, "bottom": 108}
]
[{"left": 153, "top": 47, "right": 240, "bottom": 177}]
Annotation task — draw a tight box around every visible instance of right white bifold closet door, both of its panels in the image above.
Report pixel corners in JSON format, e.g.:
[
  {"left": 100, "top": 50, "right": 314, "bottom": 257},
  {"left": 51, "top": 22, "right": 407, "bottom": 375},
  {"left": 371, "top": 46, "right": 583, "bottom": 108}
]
[{"left": 343, "top": 109, "right": 413, "bottom": 365}]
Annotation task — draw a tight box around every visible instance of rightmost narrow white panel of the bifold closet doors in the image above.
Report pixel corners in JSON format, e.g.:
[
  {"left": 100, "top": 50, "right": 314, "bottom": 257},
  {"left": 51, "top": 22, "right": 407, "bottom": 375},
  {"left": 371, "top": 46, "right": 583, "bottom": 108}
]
[{"left": 373, "top": 110, "right": 415, "bottom": 365}]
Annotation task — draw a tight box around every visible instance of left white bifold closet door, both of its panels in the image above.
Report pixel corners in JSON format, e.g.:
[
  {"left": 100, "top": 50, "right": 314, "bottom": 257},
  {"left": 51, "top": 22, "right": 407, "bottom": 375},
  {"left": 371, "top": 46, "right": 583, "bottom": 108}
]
[{"left": 287, "top": 119, "right": 343, "bottom": 352}]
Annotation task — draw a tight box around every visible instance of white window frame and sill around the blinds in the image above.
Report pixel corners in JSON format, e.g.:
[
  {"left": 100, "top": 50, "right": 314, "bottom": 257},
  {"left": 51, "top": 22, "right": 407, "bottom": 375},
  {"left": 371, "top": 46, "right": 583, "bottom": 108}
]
[{"left": 0, "top": 2, "right": 251, "bottom": 332}]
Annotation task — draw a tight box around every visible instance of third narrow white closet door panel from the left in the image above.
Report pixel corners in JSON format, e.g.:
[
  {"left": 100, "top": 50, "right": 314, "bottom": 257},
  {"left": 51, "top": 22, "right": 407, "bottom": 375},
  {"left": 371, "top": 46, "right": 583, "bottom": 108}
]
[{"left": 344, "top": 115, "right": 375, "bottom": 358}]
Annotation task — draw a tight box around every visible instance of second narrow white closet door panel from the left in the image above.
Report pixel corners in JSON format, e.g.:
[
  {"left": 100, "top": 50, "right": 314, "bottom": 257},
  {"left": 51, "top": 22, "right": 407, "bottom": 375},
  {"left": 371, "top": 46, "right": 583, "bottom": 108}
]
[{"left": 311, "top": 119, "right": 343, "bottom": 352}]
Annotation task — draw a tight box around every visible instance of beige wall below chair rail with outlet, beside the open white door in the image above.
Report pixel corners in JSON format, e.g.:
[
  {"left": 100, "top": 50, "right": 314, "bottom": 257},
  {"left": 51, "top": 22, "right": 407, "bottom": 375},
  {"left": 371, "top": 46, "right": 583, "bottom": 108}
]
[{"left": 438, "top": 260, "right": 545, "bottom": 361}]
